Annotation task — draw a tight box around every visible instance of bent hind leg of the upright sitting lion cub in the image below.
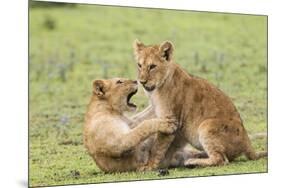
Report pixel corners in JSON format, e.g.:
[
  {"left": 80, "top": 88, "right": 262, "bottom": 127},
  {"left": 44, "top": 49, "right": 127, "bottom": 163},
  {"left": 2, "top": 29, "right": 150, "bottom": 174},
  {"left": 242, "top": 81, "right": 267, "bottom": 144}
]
[{"left": 185, "top": 119, "right": 245, "bottom": 168}]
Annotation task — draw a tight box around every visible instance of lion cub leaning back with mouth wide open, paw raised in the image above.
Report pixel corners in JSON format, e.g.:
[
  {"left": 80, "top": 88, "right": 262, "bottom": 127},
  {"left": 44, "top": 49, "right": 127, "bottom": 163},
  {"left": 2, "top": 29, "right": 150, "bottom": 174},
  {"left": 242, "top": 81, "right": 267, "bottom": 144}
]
[{"left": 84, "top": 78, "right": 175, "bottom": 172}]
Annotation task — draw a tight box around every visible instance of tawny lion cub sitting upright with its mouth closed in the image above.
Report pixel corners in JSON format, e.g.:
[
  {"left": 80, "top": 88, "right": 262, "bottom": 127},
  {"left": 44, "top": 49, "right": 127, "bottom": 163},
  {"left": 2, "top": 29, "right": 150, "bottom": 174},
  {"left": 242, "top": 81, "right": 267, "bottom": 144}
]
[{"left": 134, "top": 40, "right": 267, "bottom": 170}]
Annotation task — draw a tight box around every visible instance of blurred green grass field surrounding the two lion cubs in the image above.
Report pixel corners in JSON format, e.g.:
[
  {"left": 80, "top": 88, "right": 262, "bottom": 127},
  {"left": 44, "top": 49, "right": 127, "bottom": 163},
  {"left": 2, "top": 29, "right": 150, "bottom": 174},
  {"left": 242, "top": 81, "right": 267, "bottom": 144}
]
[{"left": 29, "top": 2, "right": 267, "bottom": 186}]
